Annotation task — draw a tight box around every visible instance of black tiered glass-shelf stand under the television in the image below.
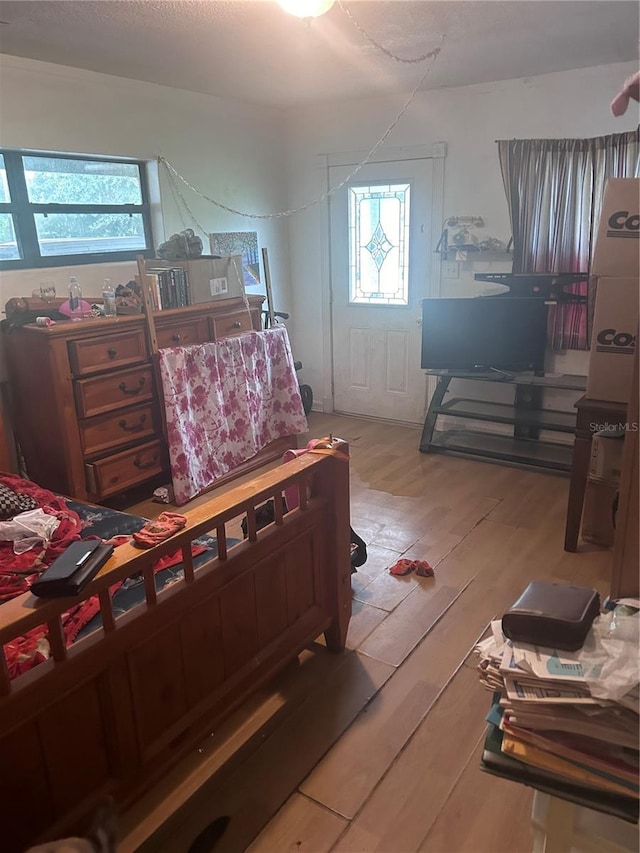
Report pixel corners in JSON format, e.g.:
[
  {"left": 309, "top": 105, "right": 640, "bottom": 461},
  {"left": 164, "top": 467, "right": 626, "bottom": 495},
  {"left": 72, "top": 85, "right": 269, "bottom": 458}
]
[{"left": 420, "top": 370, "right": 586, "bottom": 473}]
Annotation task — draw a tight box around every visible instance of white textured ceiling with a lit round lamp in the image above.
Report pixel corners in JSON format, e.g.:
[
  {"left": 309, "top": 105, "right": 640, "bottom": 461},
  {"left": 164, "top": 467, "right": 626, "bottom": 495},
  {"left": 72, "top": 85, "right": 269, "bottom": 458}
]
[{"left": 0, "top": 0, "right": 640, "bottom": 108}]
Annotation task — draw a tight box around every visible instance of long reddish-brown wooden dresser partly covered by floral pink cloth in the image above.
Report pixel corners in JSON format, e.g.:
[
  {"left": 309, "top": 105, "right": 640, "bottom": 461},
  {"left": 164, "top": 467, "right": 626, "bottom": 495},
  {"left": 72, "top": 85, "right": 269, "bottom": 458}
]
[{"left": 3, "top": 296, "right": 295, "bottom": 502}]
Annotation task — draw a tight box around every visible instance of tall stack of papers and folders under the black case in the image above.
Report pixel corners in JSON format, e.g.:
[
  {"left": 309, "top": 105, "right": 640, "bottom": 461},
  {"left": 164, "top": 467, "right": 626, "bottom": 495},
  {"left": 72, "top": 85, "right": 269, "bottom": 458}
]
[{"left": 476, "top": 621, "right": 639, "bottom": 821}]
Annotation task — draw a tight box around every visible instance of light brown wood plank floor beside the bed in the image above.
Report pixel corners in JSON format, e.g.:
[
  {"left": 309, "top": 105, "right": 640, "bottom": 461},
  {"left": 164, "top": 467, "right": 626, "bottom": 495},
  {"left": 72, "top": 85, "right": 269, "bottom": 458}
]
[{"left": 121, "top": 414, "right": 611, "bottom": 853}]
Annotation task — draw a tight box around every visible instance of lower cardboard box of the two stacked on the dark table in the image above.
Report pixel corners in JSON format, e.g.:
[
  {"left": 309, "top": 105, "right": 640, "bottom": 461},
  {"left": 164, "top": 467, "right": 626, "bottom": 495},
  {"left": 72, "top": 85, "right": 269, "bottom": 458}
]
[{"left": 587, "top": 276, "right": 640, "bottom": 403}]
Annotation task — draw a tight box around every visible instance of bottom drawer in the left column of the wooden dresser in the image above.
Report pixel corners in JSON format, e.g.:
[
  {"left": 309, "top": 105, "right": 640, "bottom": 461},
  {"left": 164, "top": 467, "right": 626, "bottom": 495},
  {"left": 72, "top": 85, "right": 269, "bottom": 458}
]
[{"left": 85, "top": 441, "right": 165, "bottom": 497}]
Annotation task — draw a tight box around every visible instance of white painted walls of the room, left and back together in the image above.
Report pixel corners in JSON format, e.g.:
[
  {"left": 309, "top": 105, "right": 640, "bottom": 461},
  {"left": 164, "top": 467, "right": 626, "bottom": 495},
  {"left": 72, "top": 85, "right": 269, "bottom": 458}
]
[{"left": 0, "top": 56, "right": 638, "bottom": 414}]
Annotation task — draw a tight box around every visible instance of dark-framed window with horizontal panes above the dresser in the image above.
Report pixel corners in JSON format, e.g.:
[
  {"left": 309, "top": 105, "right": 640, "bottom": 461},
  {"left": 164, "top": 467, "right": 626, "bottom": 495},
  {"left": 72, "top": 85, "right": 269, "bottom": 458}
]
[{"left": 0, "top": 150, "right": 153, "bottom": 269}]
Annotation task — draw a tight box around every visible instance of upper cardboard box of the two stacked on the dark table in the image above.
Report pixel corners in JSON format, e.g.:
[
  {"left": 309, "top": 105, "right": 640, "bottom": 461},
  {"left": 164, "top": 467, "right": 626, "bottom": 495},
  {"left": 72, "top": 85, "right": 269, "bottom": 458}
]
[{"left": 591, "top": 178, "right": 640, "bottom": 277}]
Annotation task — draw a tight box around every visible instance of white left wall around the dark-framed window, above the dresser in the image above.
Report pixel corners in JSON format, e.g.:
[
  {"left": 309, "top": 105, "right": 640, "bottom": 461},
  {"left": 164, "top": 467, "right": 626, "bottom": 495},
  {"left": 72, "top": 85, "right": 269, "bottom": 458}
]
[{"left": 0, "top": 56, "right": 290, "bottom": 308}]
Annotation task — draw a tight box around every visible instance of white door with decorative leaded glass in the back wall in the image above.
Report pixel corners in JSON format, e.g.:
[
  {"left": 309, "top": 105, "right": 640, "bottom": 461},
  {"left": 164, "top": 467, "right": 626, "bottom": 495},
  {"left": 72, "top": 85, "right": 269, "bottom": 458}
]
[{"left": 329, "top": 158, "right": 440, "bottom": 423}]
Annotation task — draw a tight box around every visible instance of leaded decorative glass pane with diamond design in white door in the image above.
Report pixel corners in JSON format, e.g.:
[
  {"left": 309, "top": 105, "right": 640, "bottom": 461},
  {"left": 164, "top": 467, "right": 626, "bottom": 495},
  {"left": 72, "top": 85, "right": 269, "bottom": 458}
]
[{"left": 349, "top": 181, "right": 411, "bottom": 305}]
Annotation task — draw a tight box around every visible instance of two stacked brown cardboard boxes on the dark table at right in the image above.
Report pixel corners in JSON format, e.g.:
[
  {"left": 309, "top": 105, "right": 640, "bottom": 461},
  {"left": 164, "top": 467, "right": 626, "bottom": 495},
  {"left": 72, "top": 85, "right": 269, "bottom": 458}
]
[{"left": 587, "top": 178, "right": 640, "bottom": 403}]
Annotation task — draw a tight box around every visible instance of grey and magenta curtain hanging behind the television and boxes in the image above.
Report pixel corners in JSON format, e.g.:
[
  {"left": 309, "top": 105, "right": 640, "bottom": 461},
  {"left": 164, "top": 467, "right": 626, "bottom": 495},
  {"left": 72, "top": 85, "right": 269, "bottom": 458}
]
[{"left": 498, "top": 129, "right": 640, "bottom": 350}]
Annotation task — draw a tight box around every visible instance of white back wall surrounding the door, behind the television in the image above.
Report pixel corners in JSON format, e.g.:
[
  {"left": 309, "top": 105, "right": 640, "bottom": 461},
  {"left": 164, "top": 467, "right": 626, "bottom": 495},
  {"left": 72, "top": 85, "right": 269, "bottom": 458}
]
[{"left": 287, "top": 60, "right": 638, "bottom": 400}]
